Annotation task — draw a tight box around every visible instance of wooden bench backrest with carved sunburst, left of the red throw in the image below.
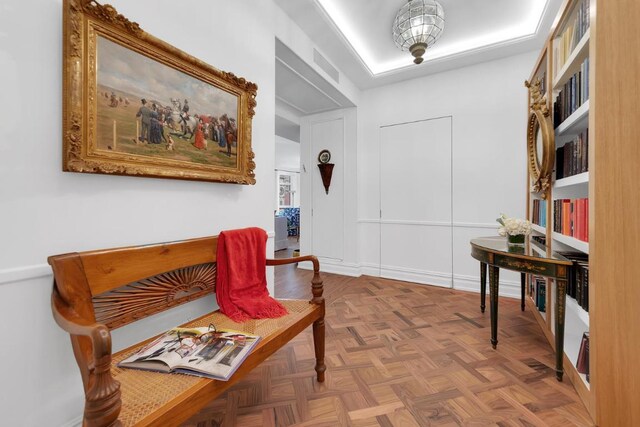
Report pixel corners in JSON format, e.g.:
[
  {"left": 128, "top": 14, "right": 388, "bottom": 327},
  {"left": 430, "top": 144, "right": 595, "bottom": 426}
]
[{"left": 48, "top": 236, "right": 218, "bottom": 329}]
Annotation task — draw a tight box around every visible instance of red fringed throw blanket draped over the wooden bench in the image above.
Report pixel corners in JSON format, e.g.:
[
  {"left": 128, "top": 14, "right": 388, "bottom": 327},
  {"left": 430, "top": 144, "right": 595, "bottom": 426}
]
[{"left": 216, "top": 227, "right": 288, "bottom": 322}]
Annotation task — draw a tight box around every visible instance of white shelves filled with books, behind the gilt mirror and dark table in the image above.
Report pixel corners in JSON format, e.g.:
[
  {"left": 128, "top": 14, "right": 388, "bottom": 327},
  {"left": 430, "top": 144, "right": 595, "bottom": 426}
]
[{"left": 527, "top": 0, "right": 596, "bottom": 419}]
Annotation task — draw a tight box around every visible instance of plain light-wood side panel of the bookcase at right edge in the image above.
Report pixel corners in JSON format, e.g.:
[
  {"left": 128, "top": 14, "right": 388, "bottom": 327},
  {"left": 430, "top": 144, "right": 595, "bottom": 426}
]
[{"left": 589, "top": 0, "right": 640, "bottom": 427}]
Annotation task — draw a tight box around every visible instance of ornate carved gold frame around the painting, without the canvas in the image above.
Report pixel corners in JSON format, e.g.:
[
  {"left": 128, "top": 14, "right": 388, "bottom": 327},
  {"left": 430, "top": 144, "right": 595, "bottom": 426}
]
[{"left": 62, "top": 0, "right": 258, "bottom": 184}]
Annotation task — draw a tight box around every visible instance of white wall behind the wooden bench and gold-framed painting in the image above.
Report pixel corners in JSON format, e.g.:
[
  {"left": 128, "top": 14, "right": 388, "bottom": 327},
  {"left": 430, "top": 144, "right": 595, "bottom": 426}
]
[{"left": 0, "top": 0, "right": 280, "bottom": 426}]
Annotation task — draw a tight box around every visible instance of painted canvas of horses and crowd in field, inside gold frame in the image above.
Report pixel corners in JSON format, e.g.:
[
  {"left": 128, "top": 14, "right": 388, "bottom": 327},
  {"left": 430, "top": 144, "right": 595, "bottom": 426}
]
[{"left": 96, "top": 37, "right": 239, "bottom": 167}]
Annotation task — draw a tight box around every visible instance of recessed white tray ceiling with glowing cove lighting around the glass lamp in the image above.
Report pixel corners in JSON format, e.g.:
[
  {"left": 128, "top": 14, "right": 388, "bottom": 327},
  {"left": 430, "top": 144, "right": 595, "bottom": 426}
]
[{"left": 275, "top": 0, "right": 562, "bottom": 89}]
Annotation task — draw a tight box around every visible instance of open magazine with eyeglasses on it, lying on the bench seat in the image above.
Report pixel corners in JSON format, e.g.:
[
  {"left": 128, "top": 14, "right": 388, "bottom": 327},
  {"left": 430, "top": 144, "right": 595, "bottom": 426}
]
[{"left": 118, "top": 326, "right": 260, "bottom": 381}]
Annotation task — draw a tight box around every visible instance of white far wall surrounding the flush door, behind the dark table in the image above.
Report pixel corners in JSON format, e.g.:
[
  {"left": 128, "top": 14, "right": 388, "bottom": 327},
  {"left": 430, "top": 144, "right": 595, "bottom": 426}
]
[{"left": 357, "top": 52, "right": 536, "bottom": 296}]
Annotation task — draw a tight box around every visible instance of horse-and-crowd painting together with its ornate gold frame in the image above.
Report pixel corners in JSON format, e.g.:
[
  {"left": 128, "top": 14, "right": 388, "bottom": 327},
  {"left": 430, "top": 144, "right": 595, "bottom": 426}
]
[{"left": 63, "top": 0, "right": 257, "bottom": 184}]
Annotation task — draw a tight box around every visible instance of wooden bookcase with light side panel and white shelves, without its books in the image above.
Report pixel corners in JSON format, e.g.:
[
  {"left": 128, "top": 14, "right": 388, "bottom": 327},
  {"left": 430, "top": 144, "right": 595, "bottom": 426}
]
[{"left": 527, "top": 0, "right": 640, "bottom": 427}]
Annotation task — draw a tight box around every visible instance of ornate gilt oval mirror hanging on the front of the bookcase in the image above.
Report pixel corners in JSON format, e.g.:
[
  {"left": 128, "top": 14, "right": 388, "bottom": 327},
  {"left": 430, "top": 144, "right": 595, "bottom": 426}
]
[{"left": 525, "top": 79, "right": 556, "bottom": 199}]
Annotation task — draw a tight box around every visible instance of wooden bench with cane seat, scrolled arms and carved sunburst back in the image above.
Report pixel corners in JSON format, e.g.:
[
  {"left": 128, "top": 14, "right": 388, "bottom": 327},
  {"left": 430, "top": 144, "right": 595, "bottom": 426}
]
[{"left": 49, "top": 236, "right": 326, "bottom": 427}]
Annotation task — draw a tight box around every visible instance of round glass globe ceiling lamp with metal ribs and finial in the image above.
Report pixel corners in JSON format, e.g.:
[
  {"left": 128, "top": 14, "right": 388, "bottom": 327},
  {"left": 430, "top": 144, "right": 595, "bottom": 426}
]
[{"left": 393, "top": 0, "right": 444, "bottom": 64}]
